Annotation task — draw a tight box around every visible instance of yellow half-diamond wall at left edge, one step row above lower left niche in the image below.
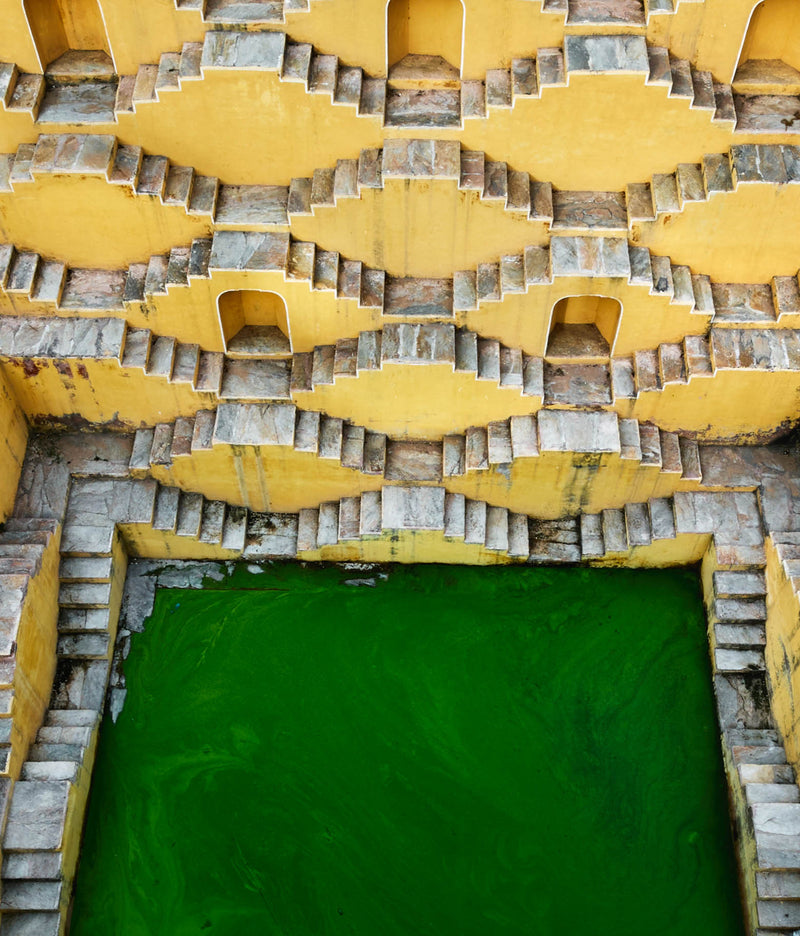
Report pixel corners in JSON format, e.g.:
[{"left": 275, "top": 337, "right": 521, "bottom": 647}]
[{"left": 0, "top": 174, "right": 211, "bottom": 270}]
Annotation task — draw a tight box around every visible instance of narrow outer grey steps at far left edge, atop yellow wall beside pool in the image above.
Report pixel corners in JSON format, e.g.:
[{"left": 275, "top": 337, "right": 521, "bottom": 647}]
[{"left": 0, "top": 517, "right": 58, "bottom": 777}]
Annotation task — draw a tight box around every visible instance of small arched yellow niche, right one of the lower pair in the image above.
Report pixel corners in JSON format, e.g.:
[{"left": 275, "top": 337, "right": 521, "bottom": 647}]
[{"left": 545, "top": 296, "right": 622, "bottom": 361}]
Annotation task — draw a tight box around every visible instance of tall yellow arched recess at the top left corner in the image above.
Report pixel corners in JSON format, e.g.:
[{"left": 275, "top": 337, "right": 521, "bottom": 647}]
[{"left": 23, "top": 0, "right": 114, "bottom": 78}]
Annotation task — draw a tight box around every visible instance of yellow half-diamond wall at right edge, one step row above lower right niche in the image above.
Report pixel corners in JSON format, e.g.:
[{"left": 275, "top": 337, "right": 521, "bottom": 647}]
[{"left": 633, "top": 182, "right": 800, "bottom": 283}]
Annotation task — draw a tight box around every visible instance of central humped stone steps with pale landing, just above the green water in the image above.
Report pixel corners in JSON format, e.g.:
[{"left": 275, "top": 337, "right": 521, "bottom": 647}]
[{"left": 297, "top": 486, "right": 530, "bottom": 559}]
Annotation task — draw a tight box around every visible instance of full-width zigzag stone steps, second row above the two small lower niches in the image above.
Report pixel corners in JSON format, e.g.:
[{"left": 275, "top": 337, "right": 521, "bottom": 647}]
[{"left": 0, "top": 134, "right": 800, "bottom": 250}]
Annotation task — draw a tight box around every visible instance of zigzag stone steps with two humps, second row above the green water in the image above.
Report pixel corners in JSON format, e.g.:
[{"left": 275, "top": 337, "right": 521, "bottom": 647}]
[{"left": 123, "top": 403, "right": 702, "bottom": 482}]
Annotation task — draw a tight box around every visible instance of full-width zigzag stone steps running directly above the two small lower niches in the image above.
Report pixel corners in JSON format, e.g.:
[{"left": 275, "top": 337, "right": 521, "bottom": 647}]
[{"left": 0, "top": 231, "right": 800, "bottom": 336}]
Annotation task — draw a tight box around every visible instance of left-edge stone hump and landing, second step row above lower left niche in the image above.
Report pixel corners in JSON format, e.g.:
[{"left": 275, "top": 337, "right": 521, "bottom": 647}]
[{"left": 0, "top": 133, "right": 287, "bottom": 228}]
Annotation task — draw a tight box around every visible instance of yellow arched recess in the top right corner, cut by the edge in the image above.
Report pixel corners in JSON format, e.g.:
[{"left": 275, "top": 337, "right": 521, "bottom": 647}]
[{"left": 733, "top": 0, "right": 800, "bottom": 94}]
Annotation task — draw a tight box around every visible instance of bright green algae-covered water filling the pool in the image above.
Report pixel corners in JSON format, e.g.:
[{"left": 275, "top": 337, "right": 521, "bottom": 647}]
[{"left": 71, "top": 565, "right": 742, "bottom": 936}]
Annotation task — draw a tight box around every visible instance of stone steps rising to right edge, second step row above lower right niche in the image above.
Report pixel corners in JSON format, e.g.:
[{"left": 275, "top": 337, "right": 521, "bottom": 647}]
[{"left": 627, "top": 143, "right": 800, "bottom": 225}]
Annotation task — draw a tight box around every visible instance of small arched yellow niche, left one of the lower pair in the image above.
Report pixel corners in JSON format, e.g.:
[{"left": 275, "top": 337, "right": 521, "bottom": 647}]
[{"left": 217, "top": 289, "right": 292, "bottom": 357}]
